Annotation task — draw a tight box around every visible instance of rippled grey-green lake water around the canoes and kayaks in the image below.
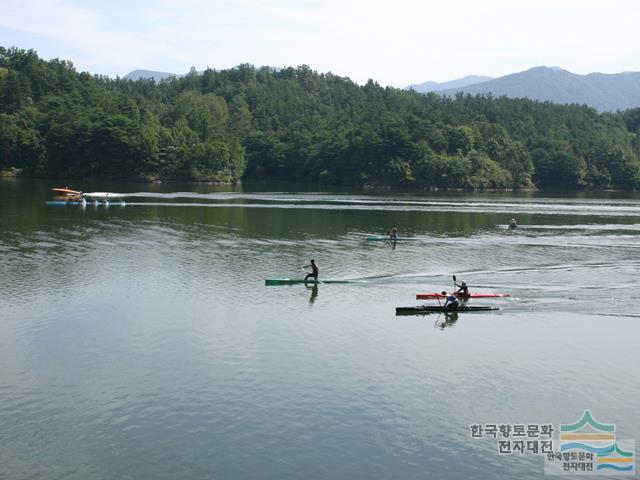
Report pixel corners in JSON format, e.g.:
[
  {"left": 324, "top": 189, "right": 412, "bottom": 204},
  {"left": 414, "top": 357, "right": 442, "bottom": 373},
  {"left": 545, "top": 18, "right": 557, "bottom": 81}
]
[{"left": 0, "top": 180, "right": 640, "bottom": 479}]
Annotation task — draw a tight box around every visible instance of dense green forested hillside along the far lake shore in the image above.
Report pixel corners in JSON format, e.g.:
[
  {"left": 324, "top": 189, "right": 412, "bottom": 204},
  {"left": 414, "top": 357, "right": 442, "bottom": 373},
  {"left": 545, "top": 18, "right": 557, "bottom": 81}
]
[{"left": 0, "top": 48, "right": 640, "bottom": 189}]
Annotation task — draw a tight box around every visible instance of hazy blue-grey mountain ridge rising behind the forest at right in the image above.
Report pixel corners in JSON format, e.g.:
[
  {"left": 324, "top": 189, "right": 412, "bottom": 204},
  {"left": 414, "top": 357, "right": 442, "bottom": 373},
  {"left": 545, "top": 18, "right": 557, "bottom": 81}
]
[{"left": 430, "top": 67, "right": 640, "bottom": 112}]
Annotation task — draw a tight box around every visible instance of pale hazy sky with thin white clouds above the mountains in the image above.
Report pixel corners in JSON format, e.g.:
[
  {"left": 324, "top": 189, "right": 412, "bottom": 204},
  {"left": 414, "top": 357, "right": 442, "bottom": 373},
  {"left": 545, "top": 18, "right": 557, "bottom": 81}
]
[{"left": 0, "top": 0, "right": 640, "bottom": 87}]
